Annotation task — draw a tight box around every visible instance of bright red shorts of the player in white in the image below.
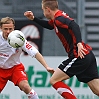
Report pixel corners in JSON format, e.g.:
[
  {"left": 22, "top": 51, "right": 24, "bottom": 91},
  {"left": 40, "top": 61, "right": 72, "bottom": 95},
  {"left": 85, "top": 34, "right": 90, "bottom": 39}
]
[{"left": 0, "top": 64, "right": 28, "bottom": 92}]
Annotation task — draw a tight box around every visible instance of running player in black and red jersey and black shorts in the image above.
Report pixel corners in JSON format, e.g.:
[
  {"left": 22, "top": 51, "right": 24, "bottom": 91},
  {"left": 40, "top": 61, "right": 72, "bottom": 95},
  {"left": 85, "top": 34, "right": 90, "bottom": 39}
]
[{"left": 24, "top": 0, "right": 99, "bottom": 99}]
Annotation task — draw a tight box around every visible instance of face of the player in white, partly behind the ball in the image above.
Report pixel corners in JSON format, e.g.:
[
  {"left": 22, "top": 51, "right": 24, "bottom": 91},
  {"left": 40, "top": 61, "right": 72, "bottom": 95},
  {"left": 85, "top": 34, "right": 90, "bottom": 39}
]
[{"left": 1, "top": 22, "right": 14, "bottom": 39}]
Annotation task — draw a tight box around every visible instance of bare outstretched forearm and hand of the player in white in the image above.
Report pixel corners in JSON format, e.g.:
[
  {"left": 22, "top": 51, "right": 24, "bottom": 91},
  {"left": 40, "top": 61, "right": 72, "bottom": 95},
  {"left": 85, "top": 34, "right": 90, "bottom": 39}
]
[{"left": 35, "top": 52, "right": 54, "bottom": 74}]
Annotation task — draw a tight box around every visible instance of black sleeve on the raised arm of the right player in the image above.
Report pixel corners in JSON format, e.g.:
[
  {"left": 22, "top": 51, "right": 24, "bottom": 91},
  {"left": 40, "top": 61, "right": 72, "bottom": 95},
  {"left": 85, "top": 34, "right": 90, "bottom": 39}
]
[{"left": 33, "top": 17, "right": 54, "bottom": 30}]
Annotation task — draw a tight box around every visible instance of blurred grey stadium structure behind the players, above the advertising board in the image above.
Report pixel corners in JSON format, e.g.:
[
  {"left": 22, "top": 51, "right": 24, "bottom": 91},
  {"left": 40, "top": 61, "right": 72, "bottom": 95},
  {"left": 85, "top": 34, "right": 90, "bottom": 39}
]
[{"left": 0, "top": 0, "right": 99, "bottom": 56}]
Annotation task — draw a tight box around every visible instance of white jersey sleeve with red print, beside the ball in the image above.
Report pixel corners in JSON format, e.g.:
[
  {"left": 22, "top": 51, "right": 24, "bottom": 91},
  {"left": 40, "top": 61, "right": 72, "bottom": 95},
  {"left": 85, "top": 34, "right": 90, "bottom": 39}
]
[{"left": 22, "top": 40, "right": 38, "bottom": 57}]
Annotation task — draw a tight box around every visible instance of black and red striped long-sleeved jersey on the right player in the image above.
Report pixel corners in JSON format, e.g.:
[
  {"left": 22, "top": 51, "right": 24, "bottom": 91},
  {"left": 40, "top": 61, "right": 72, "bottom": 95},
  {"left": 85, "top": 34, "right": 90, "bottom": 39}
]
[{"left": 34, "top": 10, "right": 91, "bottom": 57}]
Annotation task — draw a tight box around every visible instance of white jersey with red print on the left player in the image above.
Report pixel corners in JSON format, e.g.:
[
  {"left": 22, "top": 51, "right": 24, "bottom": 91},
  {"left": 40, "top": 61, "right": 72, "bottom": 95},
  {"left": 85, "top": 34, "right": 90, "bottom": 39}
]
[{"left": 0, "top": 32, "right": 38, "bottom": 69}]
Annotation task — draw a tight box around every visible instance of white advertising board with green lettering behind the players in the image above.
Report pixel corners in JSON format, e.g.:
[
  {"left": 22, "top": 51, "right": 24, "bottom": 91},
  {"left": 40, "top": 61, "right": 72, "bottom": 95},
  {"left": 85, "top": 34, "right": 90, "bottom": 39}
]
[{"left": 0, "top": 56, "right": 99, "bottom": 99}]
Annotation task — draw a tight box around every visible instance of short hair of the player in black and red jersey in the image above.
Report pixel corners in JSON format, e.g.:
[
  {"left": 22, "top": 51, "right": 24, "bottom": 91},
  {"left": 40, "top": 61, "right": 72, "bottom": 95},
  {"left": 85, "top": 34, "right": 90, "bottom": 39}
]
[{"left": 42, "top": 0, "right": 58, "bottom": 10}]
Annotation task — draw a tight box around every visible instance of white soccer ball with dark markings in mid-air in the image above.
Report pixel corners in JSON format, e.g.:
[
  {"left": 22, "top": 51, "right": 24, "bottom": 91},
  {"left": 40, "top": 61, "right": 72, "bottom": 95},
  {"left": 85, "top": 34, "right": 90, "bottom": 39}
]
[{"left": 7, "top": 30, "right": 25, "bottom": 48}]
